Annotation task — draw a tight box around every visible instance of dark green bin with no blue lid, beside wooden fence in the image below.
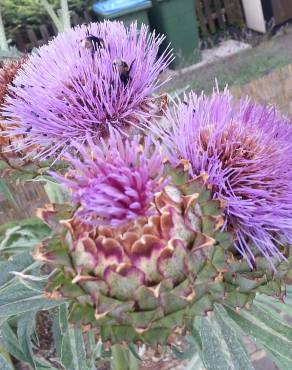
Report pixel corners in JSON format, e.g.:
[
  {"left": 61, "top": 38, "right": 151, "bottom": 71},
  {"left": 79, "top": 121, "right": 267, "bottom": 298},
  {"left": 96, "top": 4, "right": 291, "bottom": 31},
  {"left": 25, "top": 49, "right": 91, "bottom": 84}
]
[{"left": 149, "top": 0, "right": 201, "bottom": 69}]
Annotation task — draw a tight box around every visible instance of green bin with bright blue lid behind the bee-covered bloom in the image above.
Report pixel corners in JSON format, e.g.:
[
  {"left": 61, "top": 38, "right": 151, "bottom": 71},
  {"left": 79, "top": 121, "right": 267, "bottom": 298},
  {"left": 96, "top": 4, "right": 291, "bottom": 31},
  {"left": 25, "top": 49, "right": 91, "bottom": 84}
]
[{"left": 93, "top": 0, "right": 152, "bottom": 25}]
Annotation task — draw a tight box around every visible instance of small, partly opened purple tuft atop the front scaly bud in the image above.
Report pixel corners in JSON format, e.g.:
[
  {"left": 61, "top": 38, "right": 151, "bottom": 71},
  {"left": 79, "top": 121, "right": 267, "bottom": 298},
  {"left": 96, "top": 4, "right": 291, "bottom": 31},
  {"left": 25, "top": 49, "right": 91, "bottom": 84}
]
[{"left": 53, "top": 130, "right": 167, "bottom": 226}]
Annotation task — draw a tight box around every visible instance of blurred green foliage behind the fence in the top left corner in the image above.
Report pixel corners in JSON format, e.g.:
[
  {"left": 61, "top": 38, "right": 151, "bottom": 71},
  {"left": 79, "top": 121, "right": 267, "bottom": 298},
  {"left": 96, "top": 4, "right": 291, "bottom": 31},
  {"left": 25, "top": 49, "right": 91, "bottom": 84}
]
[{"left": 0, "top": 0, "right": 94, "bottom": 39}]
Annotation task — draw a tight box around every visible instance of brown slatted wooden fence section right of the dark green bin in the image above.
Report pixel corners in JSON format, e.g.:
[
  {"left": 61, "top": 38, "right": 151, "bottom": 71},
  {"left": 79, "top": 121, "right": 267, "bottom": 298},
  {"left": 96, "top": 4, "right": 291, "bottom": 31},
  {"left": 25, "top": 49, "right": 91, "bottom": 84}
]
[{"left": 195, "top": 0, "right": 244, "bottom": 37}]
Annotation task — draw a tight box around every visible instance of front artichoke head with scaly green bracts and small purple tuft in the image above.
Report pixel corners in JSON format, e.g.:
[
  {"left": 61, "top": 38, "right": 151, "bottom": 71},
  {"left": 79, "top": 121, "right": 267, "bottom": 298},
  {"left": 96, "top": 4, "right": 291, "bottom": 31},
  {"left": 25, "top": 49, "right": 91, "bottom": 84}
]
[{"left": 34, "top": 133, "right": 288, "bottom": 346}]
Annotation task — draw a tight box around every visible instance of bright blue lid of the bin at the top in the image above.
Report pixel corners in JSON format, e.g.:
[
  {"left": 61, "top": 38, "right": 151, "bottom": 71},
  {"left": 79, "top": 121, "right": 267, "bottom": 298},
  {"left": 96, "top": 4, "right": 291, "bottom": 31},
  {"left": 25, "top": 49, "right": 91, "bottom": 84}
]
[{"left": 93, "top": 0, "right": 151, "bottom": 18}]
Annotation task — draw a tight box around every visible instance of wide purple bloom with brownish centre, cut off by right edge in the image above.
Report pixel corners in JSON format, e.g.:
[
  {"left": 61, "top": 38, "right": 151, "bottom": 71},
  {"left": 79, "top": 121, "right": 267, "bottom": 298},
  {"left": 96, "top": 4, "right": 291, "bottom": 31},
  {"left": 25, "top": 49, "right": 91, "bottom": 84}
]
[{"left": 152, "top": 91, "right": 292, "bottom": 266}]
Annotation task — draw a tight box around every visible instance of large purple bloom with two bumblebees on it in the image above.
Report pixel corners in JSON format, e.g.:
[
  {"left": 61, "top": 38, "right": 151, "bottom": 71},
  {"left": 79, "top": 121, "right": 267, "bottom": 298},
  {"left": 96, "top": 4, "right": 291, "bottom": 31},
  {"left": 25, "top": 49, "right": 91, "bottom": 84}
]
[{"left": 5, "top": 21, "right": 172, "bottom": 157}]
